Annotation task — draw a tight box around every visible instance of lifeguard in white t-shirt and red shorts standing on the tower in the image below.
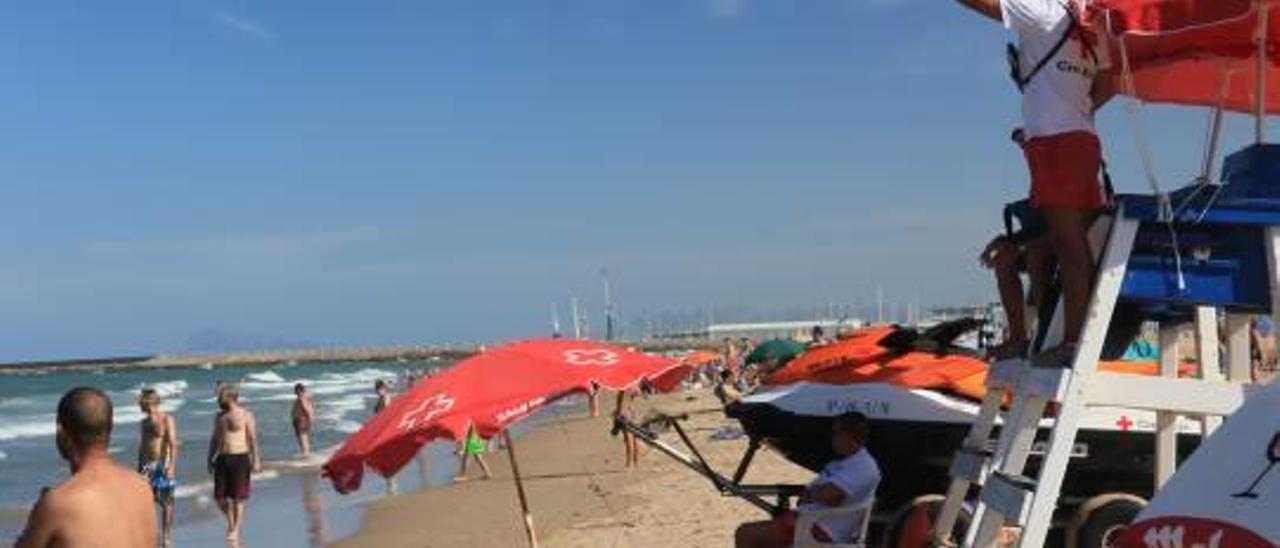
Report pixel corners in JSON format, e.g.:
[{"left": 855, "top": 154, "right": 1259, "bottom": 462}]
[{"left": 959, "top": 0, "right": 1114, "bottom": 367}]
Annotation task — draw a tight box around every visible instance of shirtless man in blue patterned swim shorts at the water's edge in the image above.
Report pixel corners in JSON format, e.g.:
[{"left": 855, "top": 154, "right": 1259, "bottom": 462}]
[{"left": 138, "top": 388, "right": 179, "bottom": 547}]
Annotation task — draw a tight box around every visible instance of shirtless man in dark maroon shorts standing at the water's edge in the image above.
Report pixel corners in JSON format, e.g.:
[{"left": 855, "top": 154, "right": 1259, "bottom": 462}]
[{"left": 209, "top": 388, "right": 262, "bottom": 543}]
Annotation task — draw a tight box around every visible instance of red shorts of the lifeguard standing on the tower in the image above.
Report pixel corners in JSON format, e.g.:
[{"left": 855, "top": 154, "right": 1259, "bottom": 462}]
[{"left": 1023, "top": 132, "right": 1102, "bottom": 210}]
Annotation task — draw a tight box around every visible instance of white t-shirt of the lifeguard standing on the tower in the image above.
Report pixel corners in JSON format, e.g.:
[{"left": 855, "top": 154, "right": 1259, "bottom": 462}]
[{"left": 1000, "top": 0, "right": 1107, "bottom": 138}]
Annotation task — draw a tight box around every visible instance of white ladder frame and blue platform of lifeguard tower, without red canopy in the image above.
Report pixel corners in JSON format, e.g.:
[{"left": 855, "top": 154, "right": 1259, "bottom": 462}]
[{"left": 933, "top": 145, "right": 1280, "bottom": 548}]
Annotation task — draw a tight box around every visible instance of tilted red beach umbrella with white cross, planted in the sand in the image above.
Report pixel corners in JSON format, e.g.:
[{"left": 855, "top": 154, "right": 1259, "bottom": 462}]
[{"left": 324, "top": 339, "right": 680, "bottom": 493}]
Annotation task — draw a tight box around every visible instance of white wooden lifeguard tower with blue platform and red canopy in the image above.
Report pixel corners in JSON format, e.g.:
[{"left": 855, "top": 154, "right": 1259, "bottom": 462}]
[{"left": 933, "top": 0, "right": 1280, "bottom": 548}]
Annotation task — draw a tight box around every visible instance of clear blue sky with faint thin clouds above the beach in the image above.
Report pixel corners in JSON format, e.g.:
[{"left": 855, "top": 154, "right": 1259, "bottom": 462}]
[{"left": 0, "top": 0, "right": 1269, "bottom": 361}]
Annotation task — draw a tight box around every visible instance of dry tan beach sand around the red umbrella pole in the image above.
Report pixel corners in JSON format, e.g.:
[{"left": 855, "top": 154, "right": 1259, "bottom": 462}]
[{"left": 335, "top": 392, "right": 813, "bottom": 548}]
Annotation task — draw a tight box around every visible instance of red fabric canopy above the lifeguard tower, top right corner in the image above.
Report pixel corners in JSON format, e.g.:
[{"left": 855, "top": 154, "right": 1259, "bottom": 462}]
[{"left": 1085, "top": 0, "right": 1280, "bottom": 113}]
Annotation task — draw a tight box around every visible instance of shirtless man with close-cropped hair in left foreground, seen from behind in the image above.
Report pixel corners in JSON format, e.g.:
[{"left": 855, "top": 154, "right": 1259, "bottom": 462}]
[{"left": 17, "top": 388, "right": 159, "bottom": 548}]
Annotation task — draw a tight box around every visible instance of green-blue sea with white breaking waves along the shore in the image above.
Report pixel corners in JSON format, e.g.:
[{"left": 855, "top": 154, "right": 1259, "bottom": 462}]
[{"left": 0, "top": 361, "right": 504, "bottom": 547}]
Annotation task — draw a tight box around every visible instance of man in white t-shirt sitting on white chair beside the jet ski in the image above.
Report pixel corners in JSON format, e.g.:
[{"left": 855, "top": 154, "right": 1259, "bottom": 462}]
[{"left": 733, "top": 411, "right": 881, "bottom": 548}]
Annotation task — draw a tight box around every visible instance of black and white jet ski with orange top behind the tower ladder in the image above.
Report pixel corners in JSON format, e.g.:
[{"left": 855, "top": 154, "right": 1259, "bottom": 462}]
[{"left": 726, "top": 320, "right": 1201, "bottom": 540}]
